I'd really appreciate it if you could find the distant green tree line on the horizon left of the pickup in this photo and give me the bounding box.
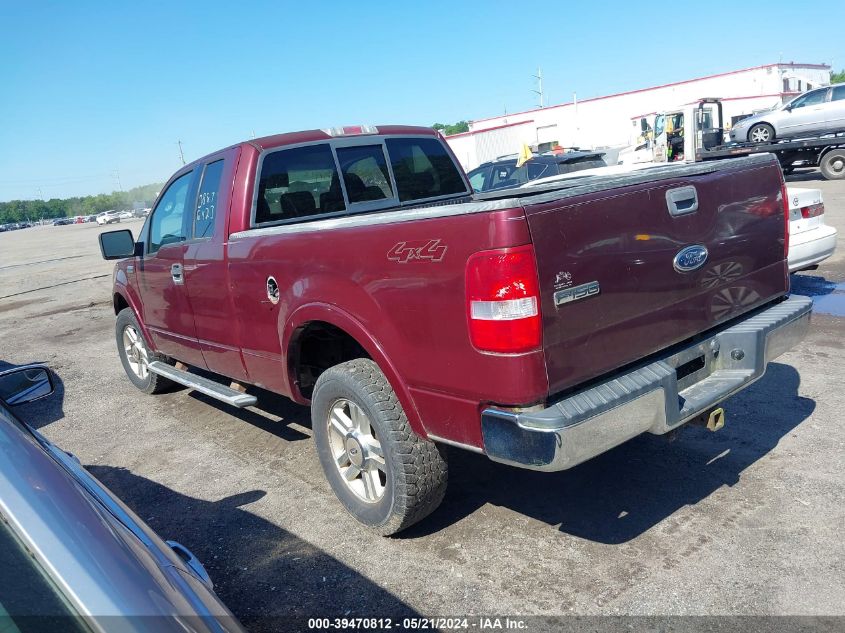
[0,183,163,224]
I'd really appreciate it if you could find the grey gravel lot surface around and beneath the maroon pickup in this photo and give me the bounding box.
[0,172,845,630]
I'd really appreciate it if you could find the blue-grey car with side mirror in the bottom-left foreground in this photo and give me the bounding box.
[0,365,242,632]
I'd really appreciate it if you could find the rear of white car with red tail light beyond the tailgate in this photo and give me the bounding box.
[787,187,836,273]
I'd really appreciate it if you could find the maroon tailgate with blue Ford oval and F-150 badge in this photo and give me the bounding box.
[523,155,789,393]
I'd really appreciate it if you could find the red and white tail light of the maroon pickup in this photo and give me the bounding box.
[466,246,541,354]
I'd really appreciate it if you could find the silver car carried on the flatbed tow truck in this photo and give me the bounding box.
[730,83,845,143]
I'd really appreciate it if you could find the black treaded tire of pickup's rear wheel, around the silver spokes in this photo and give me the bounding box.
[311,358,448,536]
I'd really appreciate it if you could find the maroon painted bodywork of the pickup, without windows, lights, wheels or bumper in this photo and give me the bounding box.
[109,126,788,448]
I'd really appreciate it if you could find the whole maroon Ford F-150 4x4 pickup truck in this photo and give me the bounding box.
[100,126,811,534]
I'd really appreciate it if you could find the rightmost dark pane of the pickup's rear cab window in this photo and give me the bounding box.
[385,138,466,202]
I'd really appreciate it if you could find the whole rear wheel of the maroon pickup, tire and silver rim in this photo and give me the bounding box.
[311,358,448,536]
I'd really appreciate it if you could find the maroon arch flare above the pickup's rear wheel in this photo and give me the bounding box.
[282,303,428,438]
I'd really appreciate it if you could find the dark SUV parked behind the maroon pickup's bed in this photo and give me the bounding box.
[467,152,606,192]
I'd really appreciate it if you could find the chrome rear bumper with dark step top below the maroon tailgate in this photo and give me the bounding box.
[481,296,813,471]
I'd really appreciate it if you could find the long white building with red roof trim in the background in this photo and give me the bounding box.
[446,62,830,170]
